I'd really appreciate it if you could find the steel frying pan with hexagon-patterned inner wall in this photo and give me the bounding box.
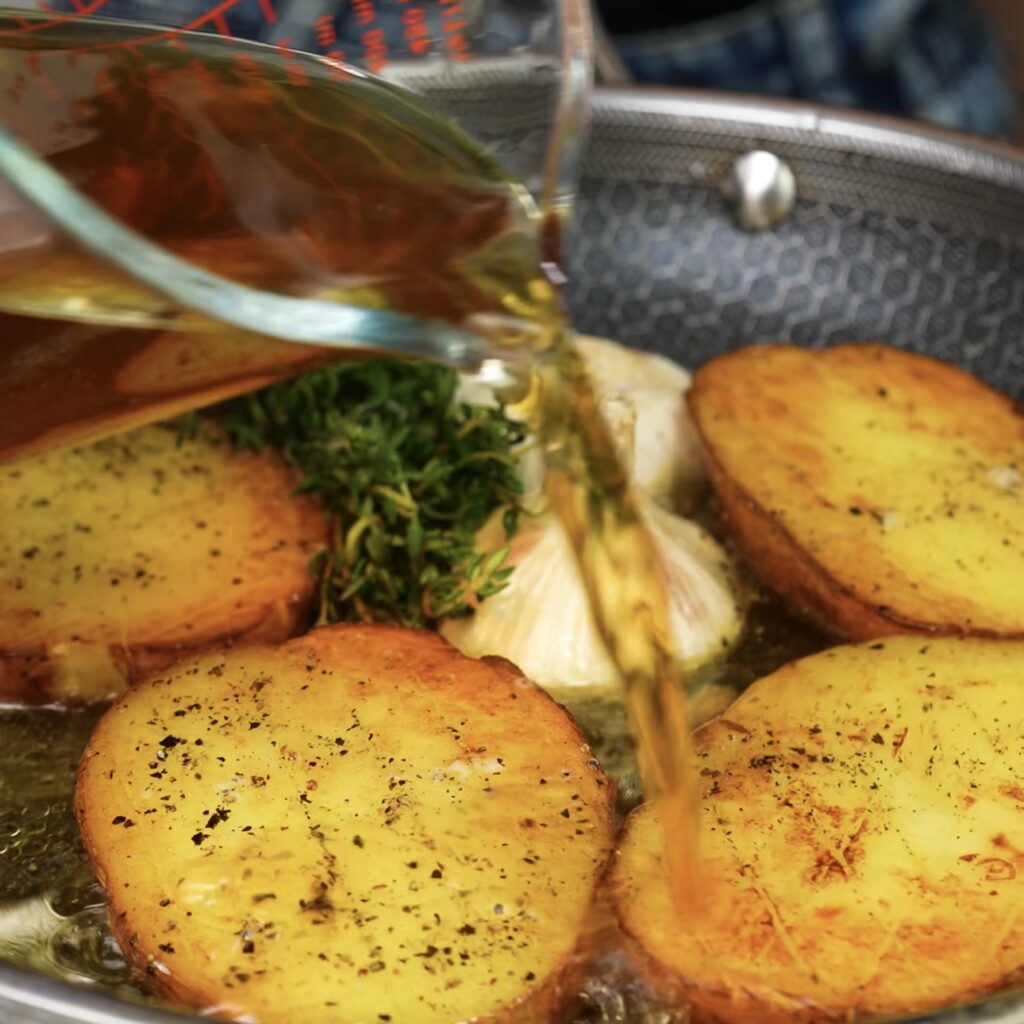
[0,89,1024,1024]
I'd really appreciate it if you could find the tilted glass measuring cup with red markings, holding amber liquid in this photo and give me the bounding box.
[0,0,589,459]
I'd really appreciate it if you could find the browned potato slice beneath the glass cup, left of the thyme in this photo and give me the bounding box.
[0,426,327,702]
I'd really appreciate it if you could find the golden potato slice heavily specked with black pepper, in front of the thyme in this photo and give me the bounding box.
[77,626,613,1024]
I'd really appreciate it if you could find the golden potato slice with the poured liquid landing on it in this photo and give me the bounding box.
[613,637,1024,1024]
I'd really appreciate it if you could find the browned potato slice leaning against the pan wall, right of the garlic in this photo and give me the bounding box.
[689,345,1024,639]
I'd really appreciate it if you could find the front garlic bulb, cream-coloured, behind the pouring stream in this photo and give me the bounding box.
[441,494,742,688]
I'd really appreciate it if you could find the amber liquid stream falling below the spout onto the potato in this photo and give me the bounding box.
[535,321,701,913]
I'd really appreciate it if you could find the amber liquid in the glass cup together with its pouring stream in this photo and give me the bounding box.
[0,19,697,909]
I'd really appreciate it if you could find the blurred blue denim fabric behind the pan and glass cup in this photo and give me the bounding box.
[29,0,1024,135]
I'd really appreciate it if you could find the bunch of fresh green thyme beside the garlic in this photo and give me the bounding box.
[214,359,524,626]
